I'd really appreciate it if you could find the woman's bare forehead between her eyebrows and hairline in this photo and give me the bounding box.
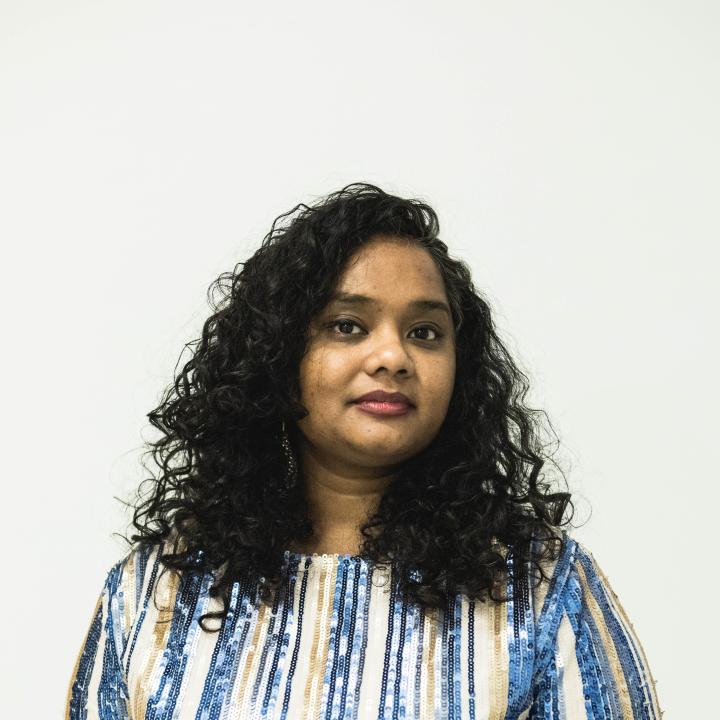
[335,236,446,302]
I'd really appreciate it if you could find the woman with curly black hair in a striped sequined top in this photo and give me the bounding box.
[67,184,661,720]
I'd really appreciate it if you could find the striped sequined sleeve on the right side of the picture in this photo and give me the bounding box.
[528,539,663,720]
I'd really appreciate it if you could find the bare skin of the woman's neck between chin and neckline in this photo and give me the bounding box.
[286,445,394,555]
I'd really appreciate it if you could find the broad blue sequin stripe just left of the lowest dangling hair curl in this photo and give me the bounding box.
[144,573,213,720]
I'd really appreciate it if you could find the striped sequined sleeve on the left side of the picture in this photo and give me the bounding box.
[65,553,141,720]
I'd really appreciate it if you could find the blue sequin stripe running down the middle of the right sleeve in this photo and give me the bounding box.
[565,569,617,719]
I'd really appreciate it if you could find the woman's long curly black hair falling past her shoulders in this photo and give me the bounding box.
[117,183,574,631]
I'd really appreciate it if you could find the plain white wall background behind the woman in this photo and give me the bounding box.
[0,0,720,718]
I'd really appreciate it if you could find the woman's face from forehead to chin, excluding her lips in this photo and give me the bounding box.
[298,236,455,470]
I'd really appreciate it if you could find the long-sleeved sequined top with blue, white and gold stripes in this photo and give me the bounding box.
[65,532,662,720]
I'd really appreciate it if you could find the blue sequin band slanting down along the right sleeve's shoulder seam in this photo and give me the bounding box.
[531,533,577,687]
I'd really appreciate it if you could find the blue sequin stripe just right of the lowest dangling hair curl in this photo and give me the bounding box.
[195,579,250,720]
